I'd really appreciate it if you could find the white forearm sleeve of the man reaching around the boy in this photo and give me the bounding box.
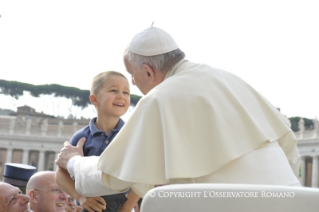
[73,156,119,197]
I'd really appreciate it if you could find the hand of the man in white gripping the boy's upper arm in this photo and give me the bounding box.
[55,137,86,169]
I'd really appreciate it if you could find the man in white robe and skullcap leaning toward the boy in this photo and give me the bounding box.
[56,27,300,207]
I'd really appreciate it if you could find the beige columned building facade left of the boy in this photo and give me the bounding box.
[0,110,90,175]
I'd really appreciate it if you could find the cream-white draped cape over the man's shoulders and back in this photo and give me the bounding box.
[75,60,299,196]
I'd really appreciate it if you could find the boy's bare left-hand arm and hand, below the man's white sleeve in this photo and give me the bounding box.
[55,166,106,212]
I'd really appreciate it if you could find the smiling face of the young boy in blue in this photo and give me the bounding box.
[95,75,130,117]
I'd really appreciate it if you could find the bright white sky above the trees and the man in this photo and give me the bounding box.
[0,0,319,119]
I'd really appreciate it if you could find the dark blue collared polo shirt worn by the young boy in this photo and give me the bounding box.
[70,118,124,156]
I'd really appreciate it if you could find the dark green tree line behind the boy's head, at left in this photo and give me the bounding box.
[0,80,141,108]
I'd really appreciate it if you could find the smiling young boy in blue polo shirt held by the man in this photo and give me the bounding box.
[56,71,139,212]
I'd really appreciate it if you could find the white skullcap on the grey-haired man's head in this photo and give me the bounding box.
[129,27,178,56]
